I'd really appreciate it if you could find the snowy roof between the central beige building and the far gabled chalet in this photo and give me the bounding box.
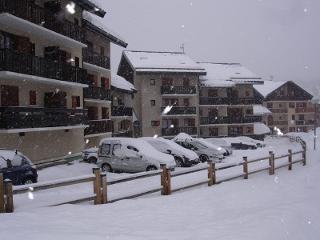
[198,62,261,87]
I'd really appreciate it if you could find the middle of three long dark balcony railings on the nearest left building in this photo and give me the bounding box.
[0,49,87,84]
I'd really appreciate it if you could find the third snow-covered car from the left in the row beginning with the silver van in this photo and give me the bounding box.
[173,135,226,162]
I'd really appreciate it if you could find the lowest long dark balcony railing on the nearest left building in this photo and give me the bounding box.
[0,107,88,129]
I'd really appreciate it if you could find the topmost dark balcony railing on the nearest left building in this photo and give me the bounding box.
[0,0,85,42]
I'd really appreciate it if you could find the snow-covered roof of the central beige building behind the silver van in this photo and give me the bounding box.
[123,51,205,74]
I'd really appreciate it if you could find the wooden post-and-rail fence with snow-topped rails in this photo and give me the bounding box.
[0,148,307,213]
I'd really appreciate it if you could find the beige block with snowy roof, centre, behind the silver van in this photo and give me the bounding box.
[118,51,205,138]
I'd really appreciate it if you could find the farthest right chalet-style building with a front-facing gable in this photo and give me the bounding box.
[254,81,315,133]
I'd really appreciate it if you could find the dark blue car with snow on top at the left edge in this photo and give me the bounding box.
[0,150,38,185]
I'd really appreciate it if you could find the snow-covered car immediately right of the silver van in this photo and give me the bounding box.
[141,137,200,167]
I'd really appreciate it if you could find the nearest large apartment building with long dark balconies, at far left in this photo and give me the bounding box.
[0,0,109,162]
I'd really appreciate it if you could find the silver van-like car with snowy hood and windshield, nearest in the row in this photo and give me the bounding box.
[97,138,176,173]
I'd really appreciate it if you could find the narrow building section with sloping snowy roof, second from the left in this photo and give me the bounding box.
[82,11,127,148]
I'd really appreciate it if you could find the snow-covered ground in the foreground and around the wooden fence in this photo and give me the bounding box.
[0,134,320,240]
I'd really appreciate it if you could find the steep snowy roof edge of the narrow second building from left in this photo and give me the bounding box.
[82,11,128,47]
